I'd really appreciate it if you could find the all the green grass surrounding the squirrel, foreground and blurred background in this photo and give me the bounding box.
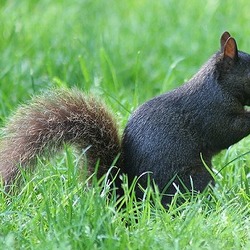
[0,0,250,249]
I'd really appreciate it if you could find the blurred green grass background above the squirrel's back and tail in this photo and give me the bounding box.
[0,0,250,123]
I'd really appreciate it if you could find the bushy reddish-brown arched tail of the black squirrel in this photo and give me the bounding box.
[0,89,120,184]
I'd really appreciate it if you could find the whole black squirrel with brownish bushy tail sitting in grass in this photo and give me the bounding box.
[0,32,250,202]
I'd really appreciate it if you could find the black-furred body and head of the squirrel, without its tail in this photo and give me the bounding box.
[122,32,250,202]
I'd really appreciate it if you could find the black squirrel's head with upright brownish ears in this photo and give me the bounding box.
[216,31,250,105]
